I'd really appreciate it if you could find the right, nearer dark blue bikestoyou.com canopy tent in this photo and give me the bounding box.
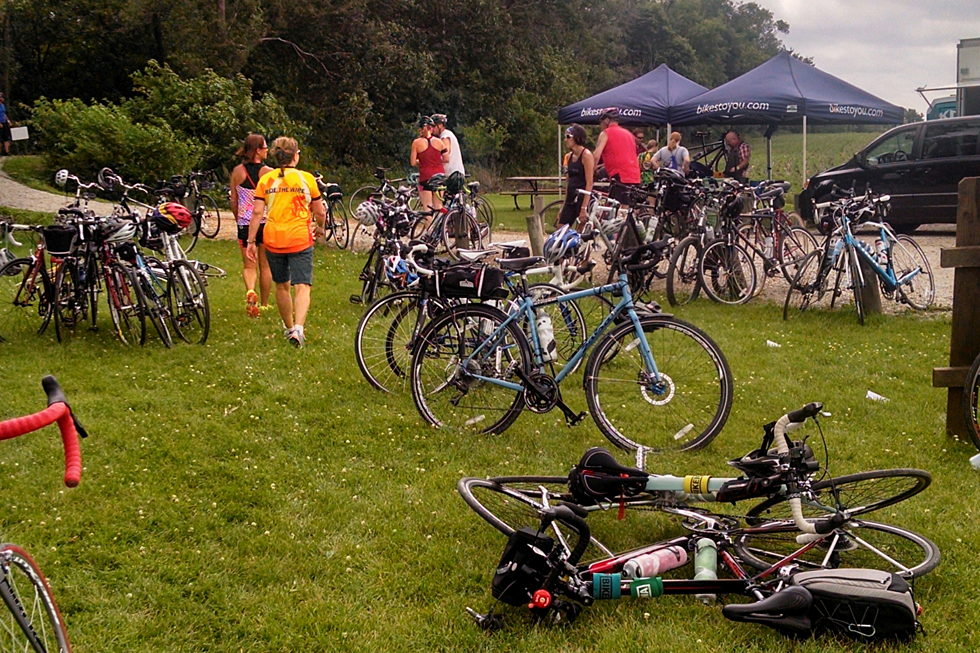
[670,52,905,178]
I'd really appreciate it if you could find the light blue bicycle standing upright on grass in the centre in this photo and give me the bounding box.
[411,243,732,450]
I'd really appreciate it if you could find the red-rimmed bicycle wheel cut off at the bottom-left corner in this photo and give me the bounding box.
[0,544,71,653]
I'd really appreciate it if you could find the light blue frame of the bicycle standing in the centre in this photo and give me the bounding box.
[460,274,661,392]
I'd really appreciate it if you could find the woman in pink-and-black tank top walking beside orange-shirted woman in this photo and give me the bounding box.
[229,134,272,317]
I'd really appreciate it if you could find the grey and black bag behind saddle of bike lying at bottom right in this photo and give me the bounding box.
[790,569,921,642]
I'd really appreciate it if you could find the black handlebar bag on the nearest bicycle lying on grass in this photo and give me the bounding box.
[490,526,555,606]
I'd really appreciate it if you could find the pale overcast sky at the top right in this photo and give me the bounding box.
[754,0,980,114]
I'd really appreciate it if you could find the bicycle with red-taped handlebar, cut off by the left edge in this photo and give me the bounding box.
[0,376,87,653]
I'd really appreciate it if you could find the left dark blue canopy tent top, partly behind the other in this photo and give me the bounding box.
[558,64,708,125]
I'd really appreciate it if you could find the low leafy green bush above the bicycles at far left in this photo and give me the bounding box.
[31,98,200,182]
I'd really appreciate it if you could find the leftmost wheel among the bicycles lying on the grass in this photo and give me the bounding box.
[456,476,613,563]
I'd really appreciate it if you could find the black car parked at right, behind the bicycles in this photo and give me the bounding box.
[796,116,980,233]
